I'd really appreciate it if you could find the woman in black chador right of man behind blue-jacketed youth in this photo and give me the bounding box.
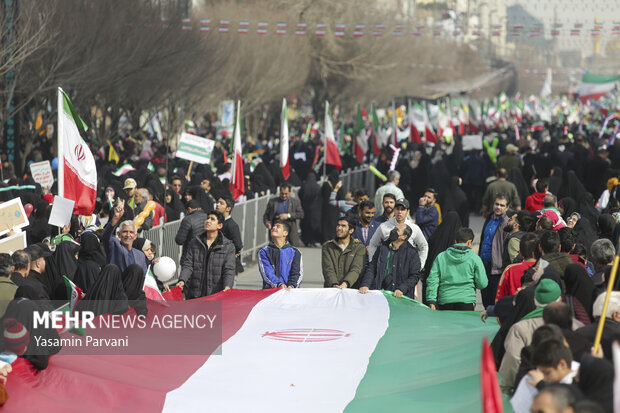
[299,172,321,246]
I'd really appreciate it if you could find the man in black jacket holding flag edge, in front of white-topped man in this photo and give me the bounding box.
[359,224,421,298]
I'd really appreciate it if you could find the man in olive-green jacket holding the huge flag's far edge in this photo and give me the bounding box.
[321,216,366,288]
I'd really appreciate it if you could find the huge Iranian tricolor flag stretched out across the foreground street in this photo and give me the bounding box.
[3,288,498,413]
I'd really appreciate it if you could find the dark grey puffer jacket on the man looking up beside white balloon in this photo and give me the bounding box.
[179,233,235,299]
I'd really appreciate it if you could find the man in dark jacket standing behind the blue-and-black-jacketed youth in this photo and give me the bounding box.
[263,182,304,247]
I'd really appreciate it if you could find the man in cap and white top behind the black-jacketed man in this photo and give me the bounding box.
[368,198,428,267]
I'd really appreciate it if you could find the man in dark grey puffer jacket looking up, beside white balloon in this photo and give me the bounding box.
[177,211,235,299]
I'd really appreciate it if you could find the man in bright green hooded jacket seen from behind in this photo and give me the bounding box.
[426,228,488,311]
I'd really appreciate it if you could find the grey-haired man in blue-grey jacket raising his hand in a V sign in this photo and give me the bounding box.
[101,201,147,274]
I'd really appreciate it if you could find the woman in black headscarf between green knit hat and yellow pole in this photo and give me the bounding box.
[564,264,595,324]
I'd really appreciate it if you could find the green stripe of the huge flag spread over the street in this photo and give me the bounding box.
[345,292,508,413]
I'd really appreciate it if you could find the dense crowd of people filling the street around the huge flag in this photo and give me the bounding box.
[0,100,620,412]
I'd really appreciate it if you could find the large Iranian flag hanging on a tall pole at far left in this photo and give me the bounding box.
[58,88,97,215]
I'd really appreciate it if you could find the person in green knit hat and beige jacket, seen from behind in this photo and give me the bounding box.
[499,278,562,393]
